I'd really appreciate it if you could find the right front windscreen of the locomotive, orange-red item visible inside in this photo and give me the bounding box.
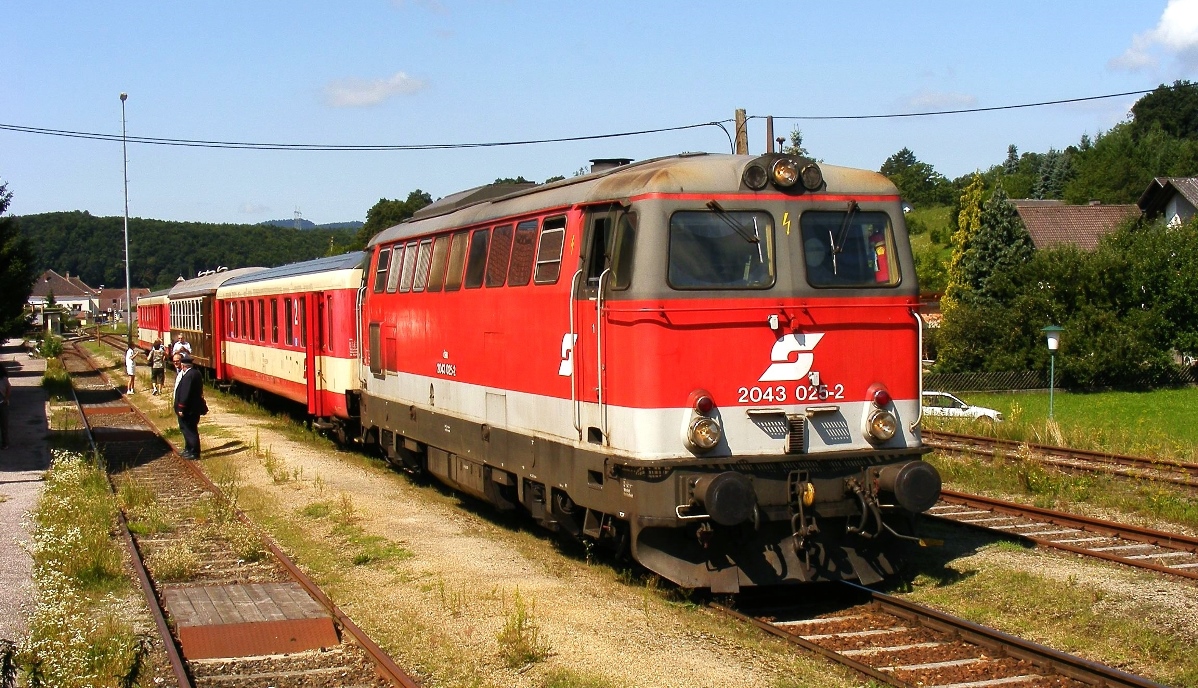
[799,204,900,288]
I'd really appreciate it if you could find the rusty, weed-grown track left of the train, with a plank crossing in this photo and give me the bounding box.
[63,346,418,688]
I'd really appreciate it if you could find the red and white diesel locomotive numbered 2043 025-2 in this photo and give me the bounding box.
[358,155,939,591]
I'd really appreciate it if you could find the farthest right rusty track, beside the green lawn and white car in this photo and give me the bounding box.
[921,430,1198,490]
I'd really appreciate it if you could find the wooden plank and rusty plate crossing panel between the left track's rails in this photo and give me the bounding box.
[163,583,340,659]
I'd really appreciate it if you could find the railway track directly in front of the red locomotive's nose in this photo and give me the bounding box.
[712,584,1160,688]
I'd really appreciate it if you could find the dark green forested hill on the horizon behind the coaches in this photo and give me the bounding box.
[17,211,355,289]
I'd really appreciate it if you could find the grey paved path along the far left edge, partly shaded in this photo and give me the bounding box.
[0,339,50,640]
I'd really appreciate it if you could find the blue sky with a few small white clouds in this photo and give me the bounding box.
[0,0,1198,223]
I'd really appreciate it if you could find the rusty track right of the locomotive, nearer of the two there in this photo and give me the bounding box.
[927,490,1198,579]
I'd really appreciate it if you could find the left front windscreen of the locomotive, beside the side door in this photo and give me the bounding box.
[668,205,774,289]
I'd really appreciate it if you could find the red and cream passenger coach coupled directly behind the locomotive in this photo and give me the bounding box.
[217,252,365,436]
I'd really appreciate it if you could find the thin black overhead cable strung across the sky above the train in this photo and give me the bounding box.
[0,89,1152,152]
